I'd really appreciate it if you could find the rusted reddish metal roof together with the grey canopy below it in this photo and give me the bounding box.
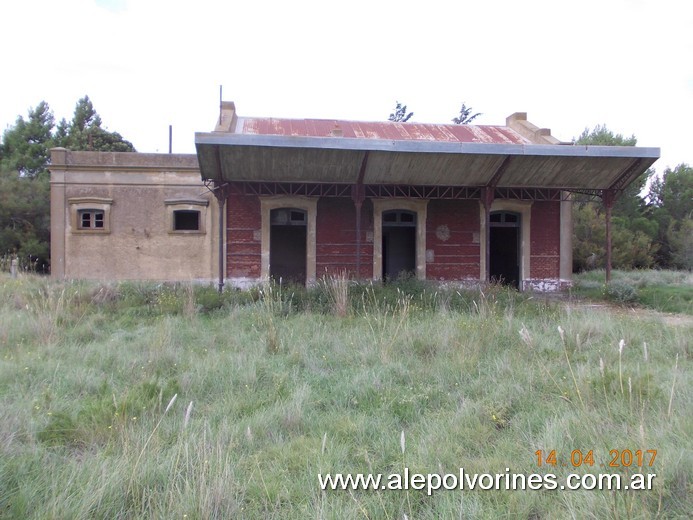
[195,107,659,191]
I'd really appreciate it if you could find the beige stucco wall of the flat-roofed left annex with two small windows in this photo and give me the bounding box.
[50,148,218,281]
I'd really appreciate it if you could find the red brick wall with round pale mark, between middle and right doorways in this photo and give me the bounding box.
[426,200,480,280]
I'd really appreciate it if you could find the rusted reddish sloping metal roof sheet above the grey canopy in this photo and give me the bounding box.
[236,117,531,144]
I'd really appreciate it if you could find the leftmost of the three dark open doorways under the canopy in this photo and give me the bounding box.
[269,208,308,285]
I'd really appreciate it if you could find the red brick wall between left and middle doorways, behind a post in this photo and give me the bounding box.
[315,198,373,278]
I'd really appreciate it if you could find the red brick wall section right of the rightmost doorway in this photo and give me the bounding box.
[529,201,561,279]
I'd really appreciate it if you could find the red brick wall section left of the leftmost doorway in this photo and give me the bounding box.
[226,192,262,278]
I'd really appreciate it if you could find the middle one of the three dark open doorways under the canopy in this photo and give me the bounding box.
[382,210,416,281]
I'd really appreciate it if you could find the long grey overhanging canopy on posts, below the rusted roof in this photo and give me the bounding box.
[195,132,659,191]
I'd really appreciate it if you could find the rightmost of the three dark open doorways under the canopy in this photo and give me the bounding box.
[489,211,520,289]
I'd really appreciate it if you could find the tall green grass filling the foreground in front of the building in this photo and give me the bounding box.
[0,275,693,519]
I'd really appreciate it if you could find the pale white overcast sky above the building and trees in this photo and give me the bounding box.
[0,0,693,172]
